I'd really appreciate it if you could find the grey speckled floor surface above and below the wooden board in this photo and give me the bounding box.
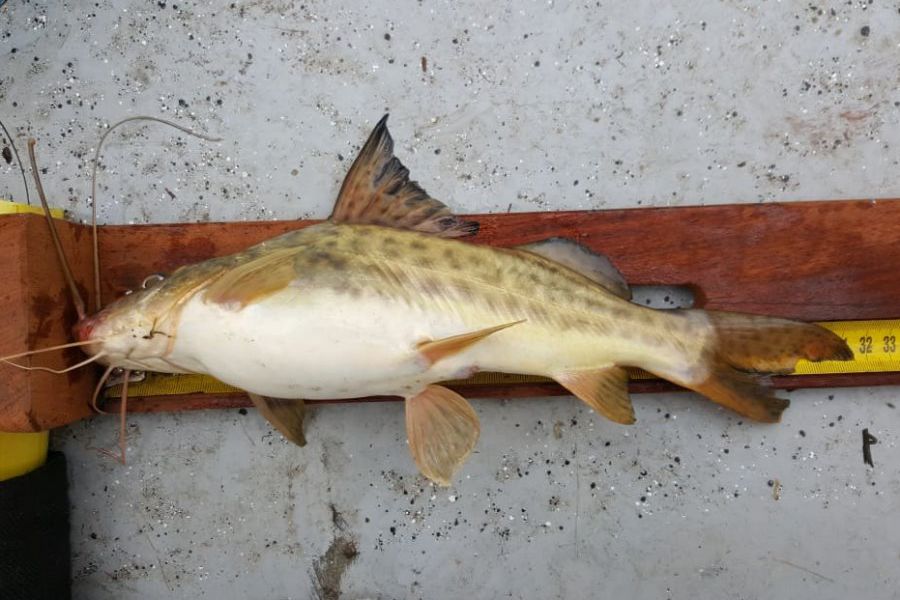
[0,0,900,599]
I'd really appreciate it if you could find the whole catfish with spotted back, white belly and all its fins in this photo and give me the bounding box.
[76,117,852,485]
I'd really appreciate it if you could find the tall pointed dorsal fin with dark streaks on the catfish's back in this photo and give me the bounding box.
[331,115,478,237]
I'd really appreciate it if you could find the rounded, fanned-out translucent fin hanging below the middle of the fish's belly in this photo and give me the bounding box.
[406,385,480,486]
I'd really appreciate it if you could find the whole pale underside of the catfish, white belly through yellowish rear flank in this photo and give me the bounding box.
[166,288,660,400]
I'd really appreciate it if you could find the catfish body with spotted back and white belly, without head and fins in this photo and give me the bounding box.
[167,223,711,399]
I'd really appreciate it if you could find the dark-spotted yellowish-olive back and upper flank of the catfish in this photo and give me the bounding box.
[220,223,686,356]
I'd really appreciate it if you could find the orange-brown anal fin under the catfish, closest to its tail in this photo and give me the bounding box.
[553,366,634,425]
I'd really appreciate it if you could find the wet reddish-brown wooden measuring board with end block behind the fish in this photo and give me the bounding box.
[0,199,900,429]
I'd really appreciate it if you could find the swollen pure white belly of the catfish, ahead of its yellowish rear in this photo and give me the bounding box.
[167,288,486,399]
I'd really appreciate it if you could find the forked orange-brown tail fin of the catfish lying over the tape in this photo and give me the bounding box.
[679,311,853,423]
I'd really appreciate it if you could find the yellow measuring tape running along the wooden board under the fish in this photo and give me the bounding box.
[107,319,900,398]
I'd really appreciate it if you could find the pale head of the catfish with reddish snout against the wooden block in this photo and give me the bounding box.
[74,278,185,372]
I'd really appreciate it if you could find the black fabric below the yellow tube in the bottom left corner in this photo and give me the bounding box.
[0,452,71,600]
